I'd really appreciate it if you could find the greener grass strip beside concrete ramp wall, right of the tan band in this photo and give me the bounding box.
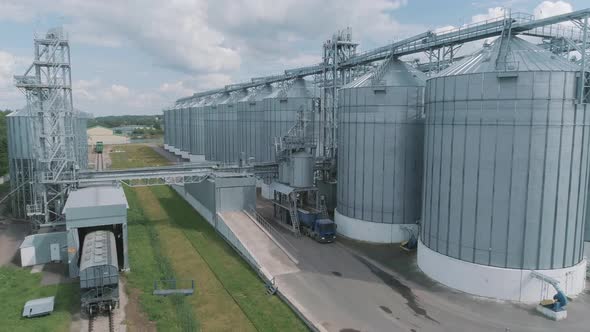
[151,187,307,331]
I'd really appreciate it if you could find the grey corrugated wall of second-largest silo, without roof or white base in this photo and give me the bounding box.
[337,87,424,224]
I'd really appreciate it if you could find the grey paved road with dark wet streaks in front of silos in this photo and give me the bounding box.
[257,198,590,332]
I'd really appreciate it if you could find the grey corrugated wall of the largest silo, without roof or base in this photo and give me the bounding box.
[421,72,590,269]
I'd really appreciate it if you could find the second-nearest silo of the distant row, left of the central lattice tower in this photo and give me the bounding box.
[237,85,273,161]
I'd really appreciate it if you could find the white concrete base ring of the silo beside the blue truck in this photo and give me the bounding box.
[334,209,417,243]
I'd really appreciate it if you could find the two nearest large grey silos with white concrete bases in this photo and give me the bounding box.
[335,37,590,303]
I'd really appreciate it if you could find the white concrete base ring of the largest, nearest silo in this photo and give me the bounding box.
[418,241,586,303]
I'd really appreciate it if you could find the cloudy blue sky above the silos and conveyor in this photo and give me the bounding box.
[0,0,590,116]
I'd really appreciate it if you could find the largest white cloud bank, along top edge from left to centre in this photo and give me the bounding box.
[0,0,421,74]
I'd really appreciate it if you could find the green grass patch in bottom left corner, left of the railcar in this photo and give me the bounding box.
[0,266,80,332]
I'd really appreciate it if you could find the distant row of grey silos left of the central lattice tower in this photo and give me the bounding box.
[164,79,319,164]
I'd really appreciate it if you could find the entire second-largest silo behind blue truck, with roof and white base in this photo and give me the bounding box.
[335,59,426,243]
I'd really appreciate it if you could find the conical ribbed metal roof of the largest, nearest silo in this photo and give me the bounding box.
[437,36,580,76]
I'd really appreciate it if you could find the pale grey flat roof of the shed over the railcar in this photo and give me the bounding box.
[64,186,129,210]
